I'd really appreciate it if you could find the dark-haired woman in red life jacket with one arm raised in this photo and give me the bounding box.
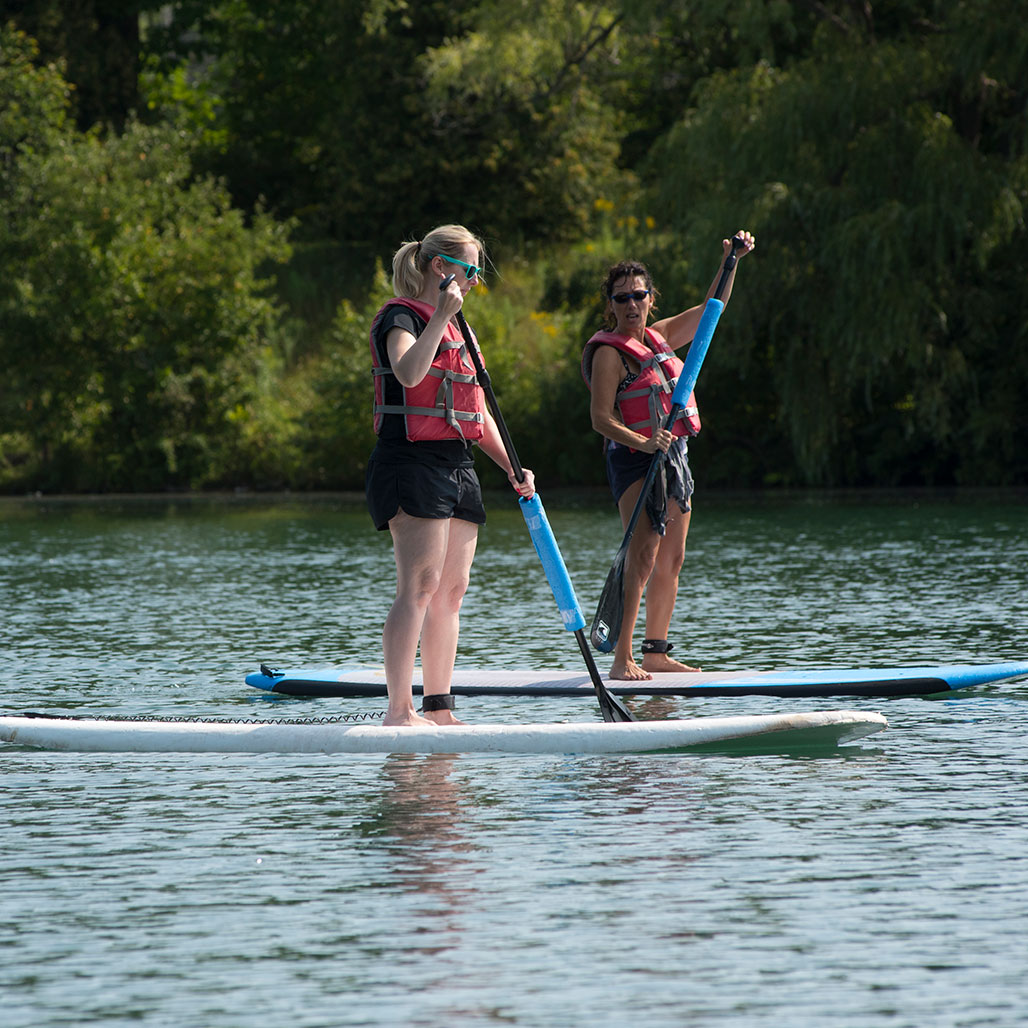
[582,231,756,682]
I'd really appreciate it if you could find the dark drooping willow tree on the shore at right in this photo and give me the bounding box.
[650,0,1028,484]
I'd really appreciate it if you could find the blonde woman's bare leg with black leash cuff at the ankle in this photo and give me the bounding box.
[421,518,478,725]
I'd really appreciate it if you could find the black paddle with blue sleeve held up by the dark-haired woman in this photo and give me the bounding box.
[589,236,743,653]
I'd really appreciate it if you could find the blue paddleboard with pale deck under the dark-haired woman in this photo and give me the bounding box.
[246,661,1028,697]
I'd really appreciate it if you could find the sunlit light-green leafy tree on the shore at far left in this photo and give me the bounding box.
[0,24,298,489]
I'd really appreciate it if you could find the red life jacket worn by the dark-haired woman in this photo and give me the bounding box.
[582,328,700,439]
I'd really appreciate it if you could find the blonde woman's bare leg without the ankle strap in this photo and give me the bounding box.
[382,510,450,725]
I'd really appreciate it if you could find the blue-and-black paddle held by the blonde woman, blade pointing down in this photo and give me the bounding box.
[439,276,637,721]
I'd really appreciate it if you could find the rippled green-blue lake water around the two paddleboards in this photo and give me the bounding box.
[0,494,1028,1028]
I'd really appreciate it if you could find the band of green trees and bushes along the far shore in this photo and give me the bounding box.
[0,0,1028,498]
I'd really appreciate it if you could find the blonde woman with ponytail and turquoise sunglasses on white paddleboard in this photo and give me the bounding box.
[366,225,535,725]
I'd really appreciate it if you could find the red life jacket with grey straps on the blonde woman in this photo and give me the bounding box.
[371,297,485,443]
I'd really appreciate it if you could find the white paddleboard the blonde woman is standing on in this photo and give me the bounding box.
[0,710,887,754]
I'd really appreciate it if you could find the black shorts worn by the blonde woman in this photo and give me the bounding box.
[364,457,485,531]
